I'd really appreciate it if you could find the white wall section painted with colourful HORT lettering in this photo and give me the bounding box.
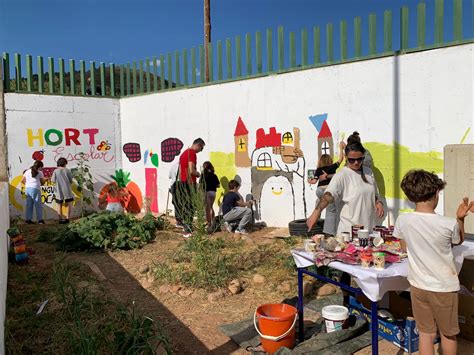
[5,93,121,218]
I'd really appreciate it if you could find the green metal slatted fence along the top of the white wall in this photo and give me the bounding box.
[2,0,474,97]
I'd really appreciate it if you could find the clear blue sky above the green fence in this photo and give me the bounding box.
[0,0,474,69]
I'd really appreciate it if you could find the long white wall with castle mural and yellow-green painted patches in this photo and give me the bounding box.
[120,44,474,226]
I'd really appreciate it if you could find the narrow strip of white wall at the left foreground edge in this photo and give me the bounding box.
[0,182,10,355]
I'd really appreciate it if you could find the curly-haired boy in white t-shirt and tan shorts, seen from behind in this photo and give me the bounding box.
[393,170,474,355]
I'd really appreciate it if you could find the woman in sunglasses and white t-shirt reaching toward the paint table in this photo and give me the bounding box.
[306,142,384,234]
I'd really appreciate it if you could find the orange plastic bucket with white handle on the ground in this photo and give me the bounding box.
[253,303,298,354]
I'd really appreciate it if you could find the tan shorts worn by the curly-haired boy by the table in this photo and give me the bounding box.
[410,286,459,336]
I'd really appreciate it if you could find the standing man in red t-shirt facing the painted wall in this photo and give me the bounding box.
[177,138,205,238]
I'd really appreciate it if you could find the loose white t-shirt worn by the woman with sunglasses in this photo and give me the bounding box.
[325,166,378,234]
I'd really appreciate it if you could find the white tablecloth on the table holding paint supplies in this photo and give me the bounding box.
[291,240,474,301]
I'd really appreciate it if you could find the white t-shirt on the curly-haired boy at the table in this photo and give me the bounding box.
[393,212,461,292]
